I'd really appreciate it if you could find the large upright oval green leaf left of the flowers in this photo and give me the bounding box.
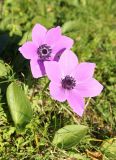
[7,82,32,128]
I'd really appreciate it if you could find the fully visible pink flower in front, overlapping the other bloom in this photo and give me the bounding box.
[44,50,103,116]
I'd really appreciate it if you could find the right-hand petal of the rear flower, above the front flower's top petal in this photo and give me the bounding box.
[53,36,74,53]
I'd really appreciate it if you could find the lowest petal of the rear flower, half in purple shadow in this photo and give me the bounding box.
[30,59,46,78]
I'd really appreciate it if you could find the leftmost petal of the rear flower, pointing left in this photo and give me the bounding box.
[19,42,38,59]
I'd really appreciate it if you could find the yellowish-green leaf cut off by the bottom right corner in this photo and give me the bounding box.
[101,138,116,160]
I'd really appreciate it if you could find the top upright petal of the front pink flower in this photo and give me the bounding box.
[58,50,78,76]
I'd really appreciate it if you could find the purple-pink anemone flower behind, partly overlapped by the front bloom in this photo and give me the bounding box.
[19,24,73,78]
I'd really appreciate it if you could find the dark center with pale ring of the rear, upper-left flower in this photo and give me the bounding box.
[37,44,52,60]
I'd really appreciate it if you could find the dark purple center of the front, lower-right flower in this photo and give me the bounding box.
[61,75,76,90]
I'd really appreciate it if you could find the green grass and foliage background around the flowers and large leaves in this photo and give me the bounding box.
[0,0,116,160]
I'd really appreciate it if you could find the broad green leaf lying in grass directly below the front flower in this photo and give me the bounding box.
[53,125,88,149]
